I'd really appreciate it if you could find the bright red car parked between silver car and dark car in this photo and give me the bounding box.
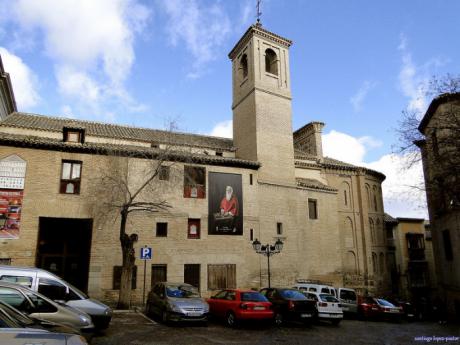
[207,289,273,327]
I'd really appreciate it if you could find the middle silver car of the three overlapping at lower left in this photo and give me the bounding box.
[0,282,94,336]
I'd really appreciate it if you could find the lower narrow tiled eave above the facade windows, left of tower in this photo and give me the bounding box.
[0,133,260,169]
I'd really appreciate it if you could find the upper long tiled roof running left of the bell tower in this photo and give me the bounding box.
[0,113,235,151]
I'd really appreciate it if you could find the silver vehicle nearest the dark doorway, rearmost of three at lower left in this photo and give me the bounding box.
[0,265,112,329]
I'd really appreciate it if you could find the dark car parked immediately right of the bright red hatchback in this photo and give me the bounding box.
[260,288,318,325]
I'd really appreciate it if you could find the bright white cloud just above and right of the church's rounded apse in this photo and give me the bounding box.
[323,130,428,218]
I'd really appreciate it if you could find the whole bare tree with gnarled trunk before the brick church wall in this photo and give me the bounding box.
[92,125,191,309]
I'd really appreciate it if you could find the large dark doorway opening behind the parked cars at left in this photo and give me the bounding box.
[35,217,93,292]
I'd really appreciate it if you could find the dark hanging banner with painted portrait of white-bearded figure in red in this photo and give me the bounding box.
[208,172,243,235]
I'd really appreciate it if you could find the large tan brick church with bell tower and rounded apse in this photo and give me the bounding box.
[0,25,389,303]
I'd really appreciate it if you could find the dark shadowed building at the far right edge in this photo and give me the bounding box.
[416,93,460,318]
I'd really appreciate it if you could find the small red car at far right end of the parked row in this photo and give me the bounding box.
[358,297,404,320]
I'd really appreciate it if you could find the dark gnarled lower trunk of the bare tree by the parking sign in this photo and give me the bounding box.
[117,211,137,309]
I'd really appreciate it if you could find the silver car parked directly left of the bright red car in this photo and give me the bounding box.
[146,282,209,322]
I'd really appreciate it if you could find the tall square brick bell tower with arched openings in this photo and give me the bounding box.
[229,24,295,185]
